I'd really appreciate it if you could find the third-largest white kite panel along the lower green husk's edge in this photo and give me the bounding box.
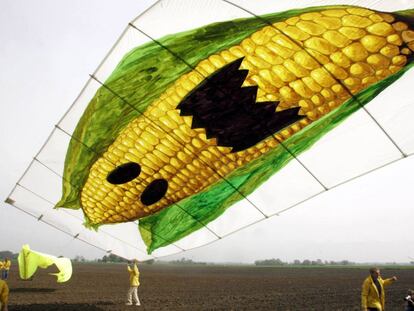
[207,200,265,237]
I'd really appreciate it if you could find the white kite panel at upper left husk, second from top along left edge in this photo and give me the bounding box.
[94,25,151,82]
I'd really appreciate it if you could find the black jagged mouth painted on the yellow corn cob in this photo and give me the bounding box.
[177,58,304,152]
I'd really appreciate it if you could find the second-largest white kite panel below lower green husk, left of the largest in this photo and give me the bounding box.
[248,160,324,216]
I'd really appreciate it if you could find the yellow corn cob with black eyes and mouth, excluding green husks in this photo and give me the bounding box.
[60,6,414,239]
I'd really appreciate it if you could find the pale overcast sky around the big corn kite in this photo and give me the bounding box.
[0,0,414,262]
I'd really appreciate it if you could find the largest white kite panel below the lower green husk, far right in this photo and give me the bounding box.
[298,110,401,188]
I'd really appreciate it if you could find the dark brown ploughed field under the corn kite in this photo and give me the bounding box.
[4,264,414,311]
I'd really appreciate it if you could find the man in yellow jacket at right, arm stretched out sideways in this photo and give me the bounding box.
[361,267,397,311]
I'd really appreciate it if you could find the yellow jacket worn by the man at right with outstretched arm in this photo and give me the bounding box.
[361,276,394,311]
